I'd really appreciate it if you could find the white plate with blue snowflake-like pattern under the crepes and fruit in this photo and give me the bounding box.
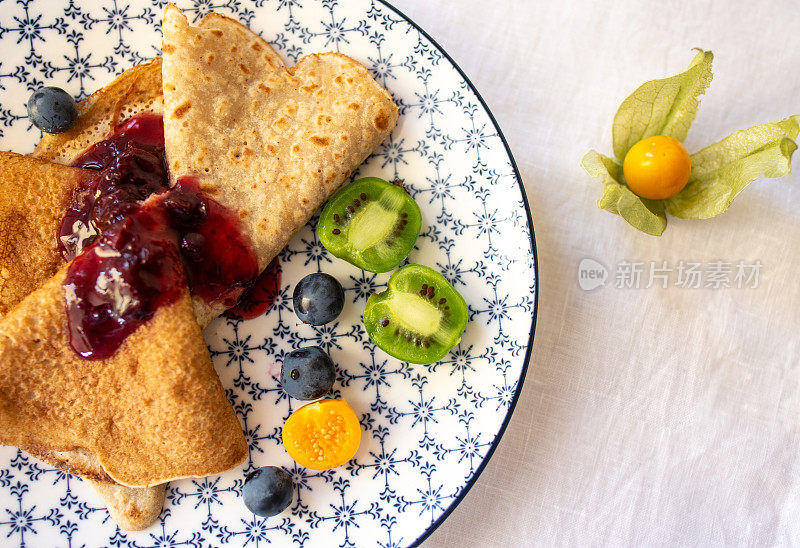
[0,0,537,547]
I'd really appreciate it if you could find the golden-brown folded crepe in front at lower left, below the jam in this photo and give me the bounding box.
[0,266,247,487]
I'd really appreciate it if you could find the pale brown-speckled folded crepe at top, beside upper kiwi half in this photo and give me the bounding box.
[162,5,398,325]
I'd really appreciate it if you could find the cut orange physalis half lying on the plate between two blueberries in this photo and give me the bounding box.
[282,400,361,470]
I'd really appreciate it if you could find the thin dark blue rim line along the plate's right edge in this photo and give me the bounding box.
[378,0,539,548]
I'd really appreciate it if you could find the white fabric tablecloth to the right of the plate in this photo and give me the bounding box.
[396,0,800,547]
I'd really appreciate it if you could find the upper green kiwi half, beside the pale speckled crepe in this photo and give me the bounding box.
[317,177,422,272]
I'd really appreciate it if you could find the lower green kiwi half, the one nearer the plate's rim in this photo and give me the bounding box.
[364,264,468,363]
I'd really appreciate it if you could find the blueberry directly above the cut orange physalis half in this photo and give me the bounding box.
[281,346,336,400]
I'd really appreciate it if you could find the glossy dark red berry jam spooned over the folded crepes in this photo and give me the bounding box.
[59,114,258,359]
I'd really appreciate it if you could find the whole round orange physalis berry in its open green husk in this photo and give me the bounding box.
[622,135,692,200]
